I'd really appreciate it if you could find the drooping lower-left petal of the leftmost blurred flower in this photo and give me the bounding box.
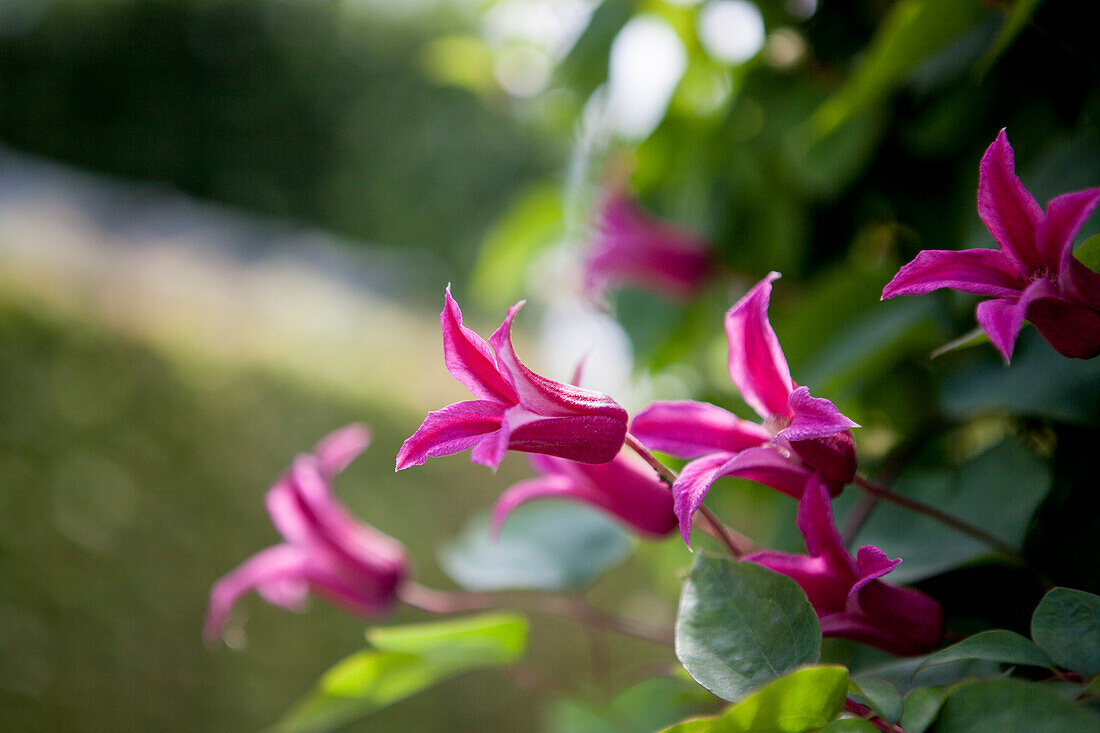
[202,545,309,644]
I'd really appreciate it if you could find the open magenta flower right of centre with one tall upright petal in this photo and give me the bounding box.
[630,272,859,543]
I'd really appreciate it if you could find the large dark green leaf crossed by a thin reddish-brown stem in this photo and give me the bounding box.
[857,433,1052,583]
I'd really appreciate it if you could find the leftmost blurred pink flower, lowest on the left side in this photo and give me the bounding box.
[204,425,409,643]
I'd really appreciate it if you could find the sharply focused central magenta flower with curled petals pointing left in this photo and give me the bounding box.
[396,287,627,471]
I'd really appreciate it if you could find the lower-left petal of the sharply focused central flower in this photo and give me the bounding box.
[395,400,505,471]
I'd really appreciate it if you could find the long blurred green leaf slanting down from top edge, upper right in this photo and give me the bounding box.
[811,0,983,139]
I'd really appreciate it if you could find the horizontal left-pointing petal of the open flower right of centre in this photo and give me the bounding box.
[630,401,771,458]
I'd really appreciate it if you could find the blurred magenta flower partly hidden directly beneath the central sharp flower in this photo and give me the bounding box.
[493,451,677,537]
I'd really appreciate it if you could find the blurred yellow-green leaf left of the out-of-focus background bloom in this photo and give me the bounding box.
[472,186,564,308]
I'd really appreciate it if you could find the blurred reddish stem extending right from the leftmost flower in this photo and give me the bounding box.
[398,581,673,646]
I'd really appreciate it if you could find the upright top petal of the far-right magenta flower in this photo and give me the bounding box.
[978,130,1043,272]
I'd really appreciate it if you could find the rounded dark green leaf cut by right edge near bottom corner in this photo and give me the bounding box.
[1032,588,1100,678]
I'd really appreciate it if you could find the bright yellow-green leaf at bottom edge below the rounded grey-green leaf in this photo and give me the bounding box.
[666,666,848,733]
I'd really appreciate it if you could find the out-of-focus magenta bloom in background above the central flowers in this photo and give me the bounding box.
[584,193,714,300]
